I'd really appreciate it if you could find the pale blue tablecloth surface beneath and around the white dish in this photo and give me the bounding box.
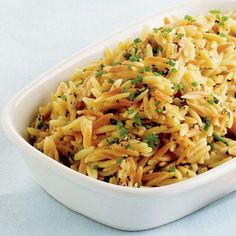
[0,0,236,236]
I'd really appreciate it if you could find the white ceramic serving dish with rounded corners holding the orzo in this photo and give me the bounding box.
[2,0,236,230]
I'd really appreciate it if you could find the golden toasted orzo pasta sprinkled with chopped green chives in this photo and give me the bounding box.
[27,10,236,187]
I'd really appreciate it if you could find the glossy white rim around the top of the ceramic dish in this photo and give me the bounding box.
[1,0,236,195]
